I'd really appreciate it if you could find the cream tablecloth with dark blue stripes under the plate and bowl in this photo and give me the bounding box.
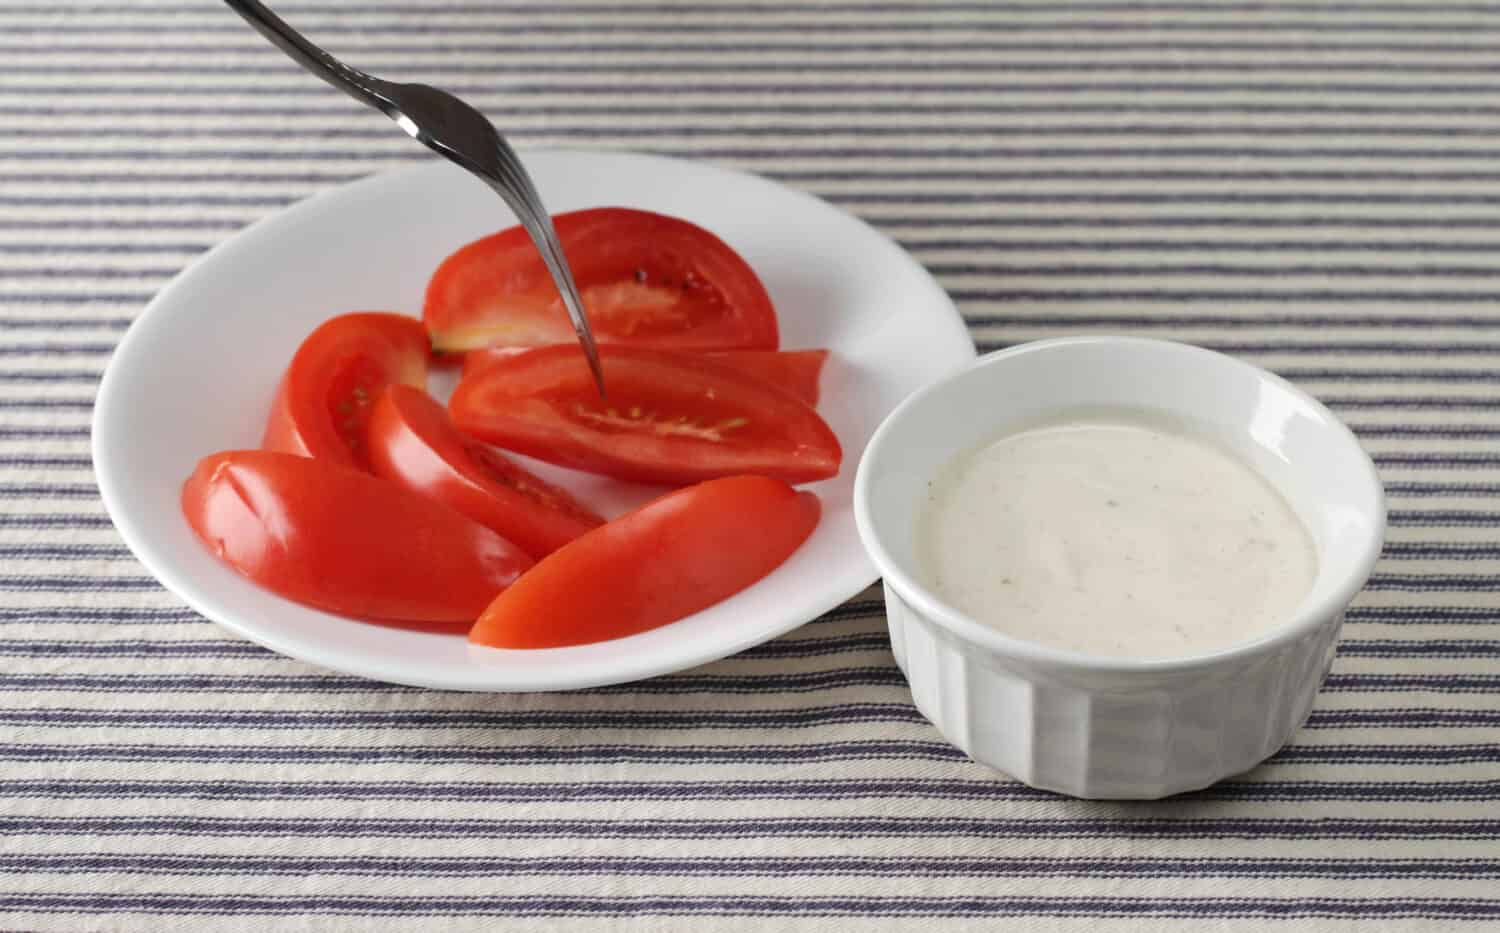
[0,0,1500,930]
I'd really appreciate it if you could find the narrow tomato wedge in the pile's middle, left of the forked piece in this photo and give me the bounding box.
[369,386,605,558]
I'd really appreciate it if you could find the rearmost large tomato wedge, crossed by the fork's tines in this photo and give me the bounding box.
[422,207,777,353]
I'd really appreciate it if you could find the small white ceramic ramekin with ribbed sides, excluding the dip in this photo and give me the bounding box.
[855,338,1386,798]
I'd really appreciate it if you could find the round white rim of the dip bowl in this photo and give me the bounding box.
[854,336,1386,674]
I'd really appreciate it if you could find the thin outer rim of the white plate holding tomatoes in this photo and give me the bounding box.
[90,147,977,693]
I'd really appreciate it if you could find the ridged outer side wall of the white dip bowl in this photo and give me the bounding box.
[885,585,1343,800]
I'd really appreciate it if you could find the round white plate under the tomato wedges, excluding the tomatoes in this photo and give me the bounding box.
[93,152,974,690]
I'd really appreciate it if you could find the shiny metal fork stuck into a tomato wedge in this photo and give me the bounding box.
[224,0,605,395]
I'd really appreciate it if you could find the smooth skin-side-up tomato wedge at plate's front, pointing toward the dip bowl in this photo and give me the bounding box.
[470,476,822,648]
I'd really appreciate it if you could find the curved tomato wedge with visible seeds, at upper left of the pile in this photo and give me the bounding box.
[261,312,428,470]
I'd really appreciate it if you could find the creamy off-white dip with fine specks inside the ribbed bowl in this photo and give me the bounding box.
[917,413,1317,659]
